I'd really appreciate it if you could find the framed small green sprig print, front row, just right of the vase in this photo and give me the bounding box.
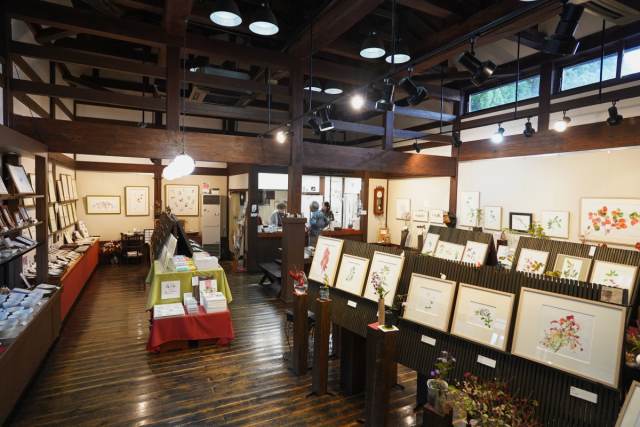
[403,273,456,332]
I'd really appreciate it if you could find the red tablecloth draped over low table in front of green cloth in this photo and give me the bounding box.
[147,305,234,353]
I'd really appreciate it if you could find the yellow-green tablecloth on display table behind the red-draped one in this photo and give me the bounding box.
[146,260,233,310]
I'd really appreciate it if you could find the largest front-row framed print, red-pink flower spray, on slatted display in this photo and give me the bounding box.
[511,288,626,388]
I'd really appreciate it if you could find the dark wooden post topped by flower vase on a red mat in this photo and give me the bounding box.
[364,323,398,427]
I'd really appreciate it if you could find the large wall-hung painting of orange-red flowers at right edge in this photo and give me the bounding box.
[580,197,640,246]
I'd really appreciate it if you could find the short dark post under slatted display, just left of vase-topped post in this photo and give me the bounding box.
[340,328,367,395]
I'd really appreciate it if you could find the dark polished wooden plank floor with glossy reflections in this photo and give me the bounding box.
[9,264,422,426]
